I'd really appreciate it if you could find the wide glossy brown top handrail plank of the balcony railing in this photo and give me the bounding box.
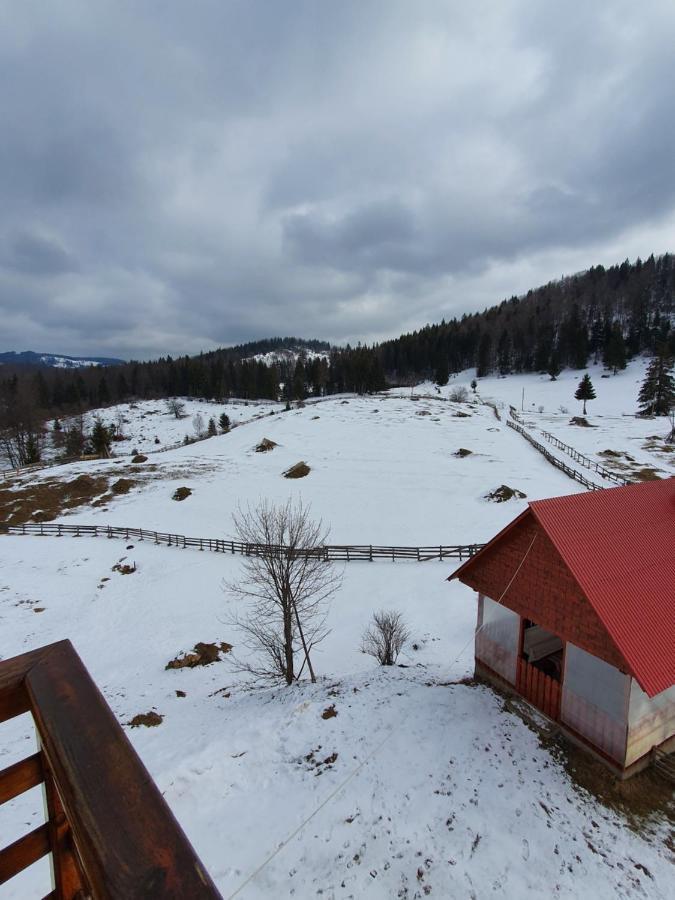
[26,641,220,900]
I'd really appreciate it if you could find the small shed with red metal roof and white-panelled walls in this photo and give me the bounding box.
[451,478,675,777]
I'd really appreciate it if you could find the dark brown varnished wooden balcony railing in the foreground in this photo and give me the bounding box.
[0,641,221,900]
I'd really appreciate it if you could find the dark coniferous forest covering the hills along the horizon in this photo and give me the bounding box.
[0,254,675,444]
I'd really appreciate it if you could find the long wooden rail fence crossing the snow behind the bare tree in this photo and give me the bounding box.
[0,522,483,562]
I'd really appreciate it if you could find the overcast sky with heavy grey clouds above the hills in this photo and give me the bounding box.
[0,0,675,358]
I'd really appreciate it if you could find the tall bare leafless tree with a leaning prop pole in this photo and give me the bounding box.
[225,500,342,684]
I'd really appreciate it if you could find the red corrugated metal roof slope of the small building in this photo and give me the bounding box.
[529,478,675,697]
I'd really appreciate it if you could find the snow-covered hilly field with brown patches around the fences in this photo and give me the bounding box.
[0,363,675,898]
